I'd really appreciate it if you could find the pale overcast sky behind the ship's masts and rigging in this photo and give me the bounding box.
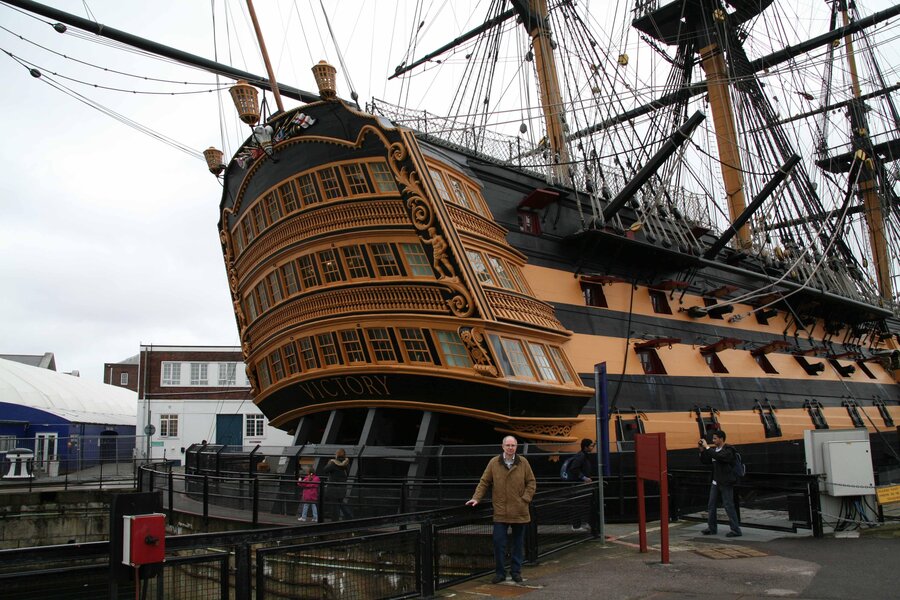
[0,0,891,381]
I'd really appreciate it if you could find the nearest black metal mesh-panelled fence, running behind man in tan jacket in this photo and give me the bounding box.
[0,485,597,600]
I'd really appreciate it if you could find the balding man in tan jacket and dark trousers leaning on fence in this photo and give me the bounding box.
[466,435,537,583]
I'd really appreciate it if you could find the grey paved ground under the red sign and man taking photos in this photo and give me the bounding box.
[437,516,900,600]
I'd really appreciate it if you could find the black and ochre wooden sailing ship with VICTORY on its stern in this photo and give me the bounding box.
[14,0,900,475]
